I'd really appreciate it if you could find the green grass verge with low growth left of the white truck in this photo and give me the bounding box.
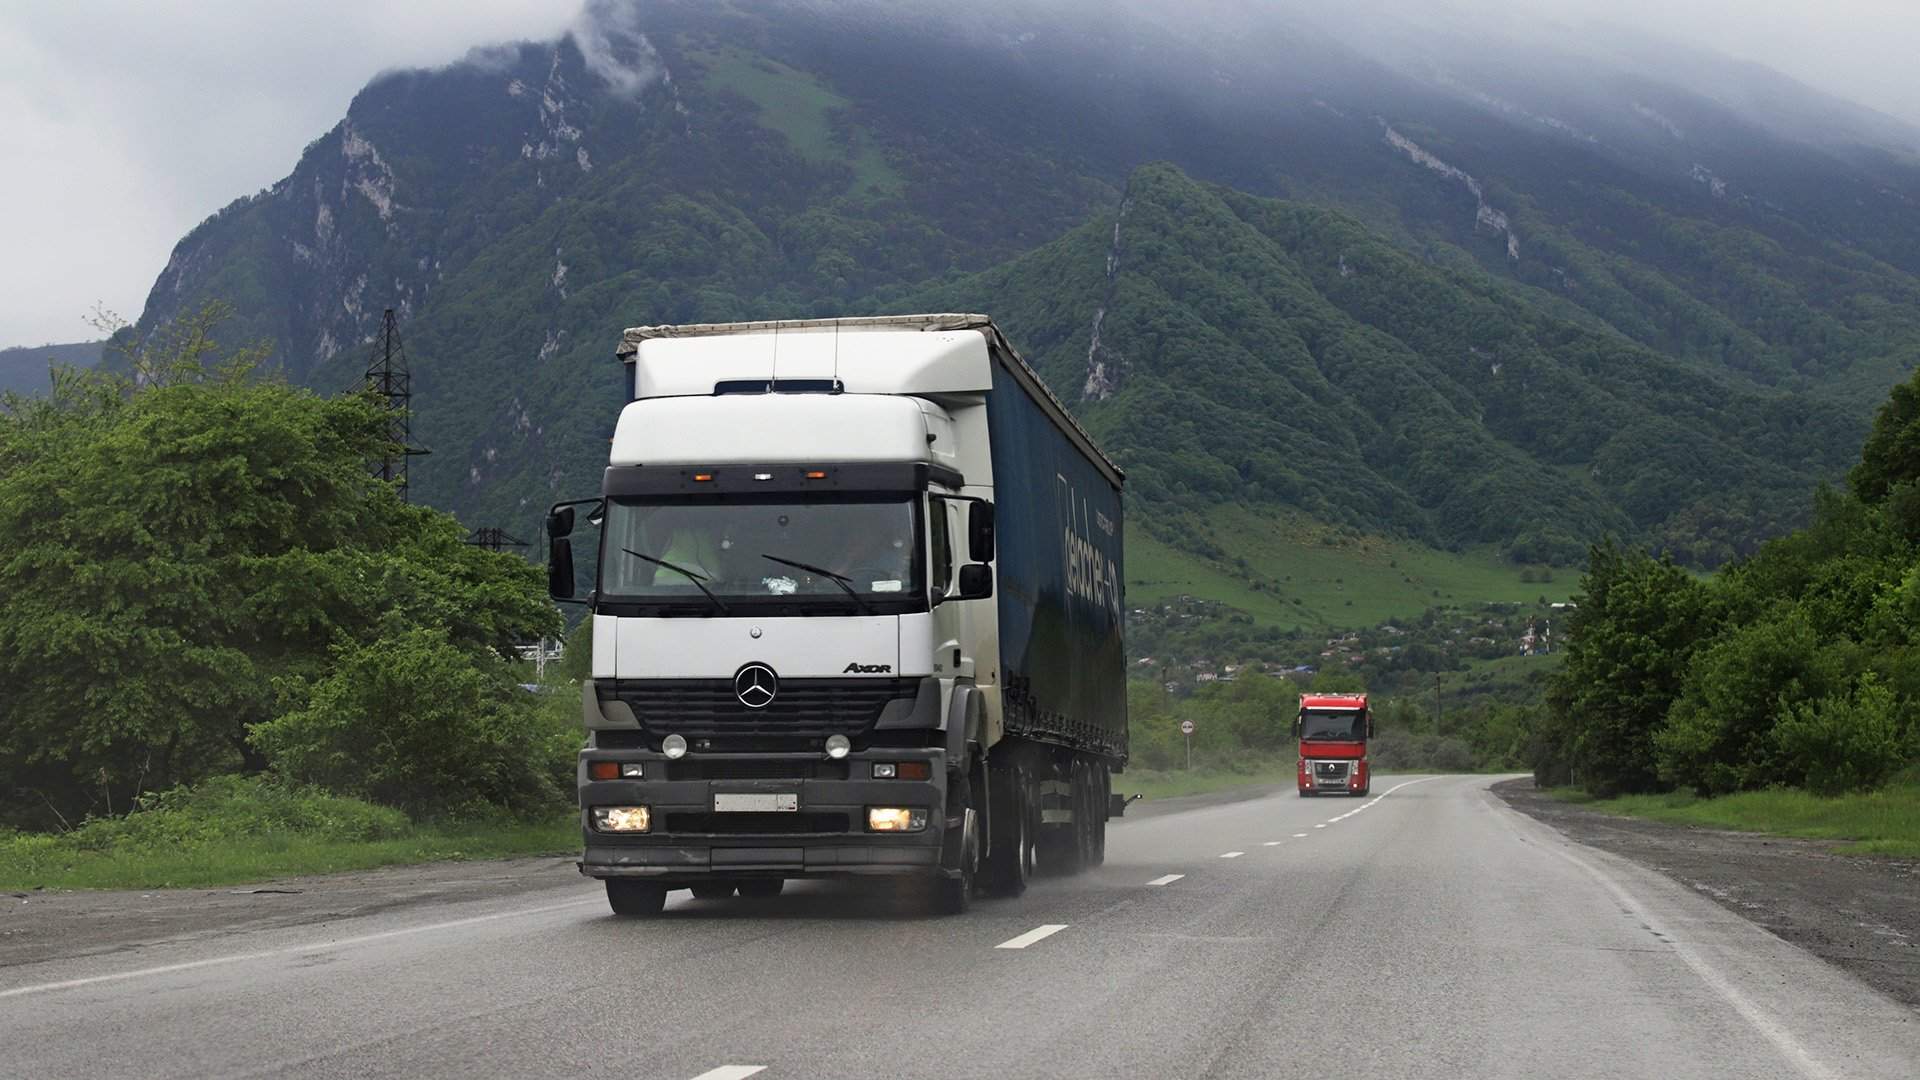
[0,778,580,892]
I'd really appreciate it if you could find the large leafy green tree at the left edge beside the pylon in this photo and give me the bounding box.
[0,307,559,819]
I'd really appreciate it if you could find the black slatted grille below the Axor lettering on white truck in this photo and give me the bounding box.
[612,678,920,738]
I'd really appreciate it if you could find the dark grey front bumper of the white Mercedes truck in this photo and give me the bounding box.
[580,749,947,884]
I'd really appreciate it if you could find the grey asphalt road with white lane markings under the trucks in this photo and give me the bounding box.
[0,776,1920,1080]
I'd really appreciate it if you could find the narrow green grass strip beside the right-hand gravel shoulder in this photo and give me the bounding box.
[1551,782,1920,859]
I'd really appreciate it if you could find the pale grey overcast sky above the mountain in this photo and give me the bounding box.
[0,0,1920,346]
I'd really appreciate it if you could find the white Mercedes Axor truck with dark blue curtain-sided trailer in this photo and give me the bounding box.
[547,315,1127,917]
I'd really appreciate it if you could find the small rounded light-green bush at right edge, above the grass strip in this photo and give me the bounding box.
[1774,673,1908,796]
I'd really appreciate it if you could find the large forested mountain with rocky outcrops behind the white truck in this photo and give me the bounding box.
[127,0,1920,580]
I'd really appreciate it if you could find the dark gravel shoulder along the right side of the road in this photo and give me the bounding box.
[1492,780,1920,1007]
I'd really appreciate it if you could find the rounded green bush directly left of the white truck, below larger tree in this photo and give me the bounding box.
[252,628,580,819]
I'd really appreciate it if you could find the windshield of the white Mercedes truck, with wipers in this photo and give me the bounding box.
[599,496,925,613]
